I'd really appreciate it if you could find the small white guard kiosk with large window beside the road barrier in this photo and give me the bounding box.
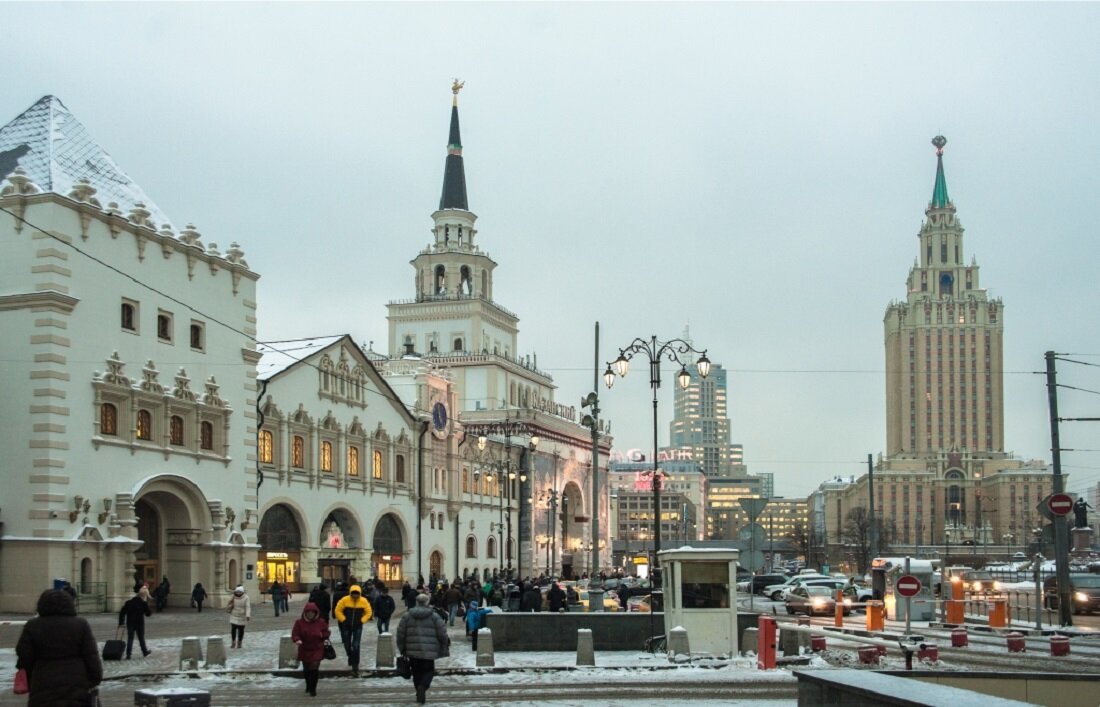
[659,546,740,656]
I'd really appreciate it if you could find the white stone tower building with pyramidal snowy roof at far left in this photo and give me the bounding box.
[0,96,259,611]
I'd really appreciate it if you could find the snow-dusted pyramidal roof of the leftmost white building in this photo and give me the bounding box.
[0,96,172,227]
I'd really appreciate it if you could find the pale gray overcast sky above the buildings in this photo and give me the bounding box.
[0,2,1100,496]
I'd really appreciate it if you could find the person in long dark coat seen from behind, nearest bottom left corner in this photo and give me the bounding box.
[15,589,103,707]
